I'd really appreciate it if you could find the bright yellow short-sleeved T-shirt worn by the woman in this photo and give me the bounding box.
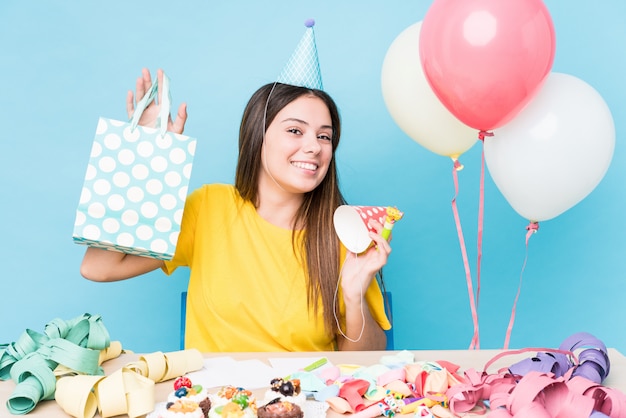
[165,184,390,352]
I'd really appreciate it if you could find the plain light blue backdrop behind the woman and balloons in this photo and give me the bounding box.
[0,0,626,352]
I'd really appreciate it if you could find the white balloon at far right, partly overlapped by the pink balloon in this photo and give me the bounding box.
[484,72,615,222]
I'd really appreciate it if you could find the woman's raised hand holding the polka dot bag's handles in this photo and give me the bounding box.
[126,68,187,134]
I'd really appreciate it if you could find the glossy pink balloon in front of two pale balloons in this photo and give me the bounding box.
[419,0,555,131]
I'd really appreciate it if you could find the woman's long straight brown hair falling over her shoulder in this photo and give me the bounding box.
[235,83,345,337]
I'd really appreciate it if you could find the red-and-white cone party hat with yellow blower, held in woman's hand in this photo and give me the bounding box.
[333,205,404,254]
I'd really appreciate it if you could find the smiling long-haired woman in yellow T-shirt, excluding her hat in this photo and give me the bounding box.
[81,69,391,352]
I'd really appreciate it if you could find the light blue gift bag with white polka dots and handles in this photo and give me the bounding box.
[73,74,196,260]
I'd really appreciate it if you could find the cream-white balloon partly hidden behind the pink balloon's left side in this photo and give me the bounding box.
[381,22,478,158]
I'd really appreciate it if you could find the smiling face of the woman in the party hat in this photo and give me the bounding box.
[260,96,333,194]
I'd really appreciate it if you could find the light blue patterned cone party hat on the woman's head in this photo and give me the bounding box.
[276,19,323,90]
